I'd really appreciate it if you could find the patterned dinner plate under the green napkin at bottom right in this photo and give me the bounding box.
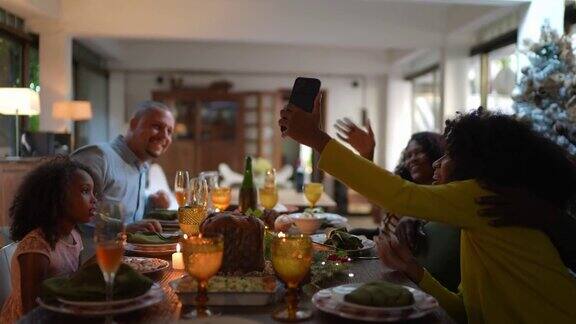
[312,284,438,322]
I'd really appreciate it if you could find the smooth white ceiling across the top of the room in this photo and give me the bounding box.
[0,0,526,70]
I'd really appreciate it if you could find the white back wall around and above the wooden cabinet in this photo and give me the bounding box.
[121,71,381,166]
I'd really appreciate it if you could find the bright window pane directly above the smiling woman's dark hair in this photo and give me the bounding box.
[408,66,442,132]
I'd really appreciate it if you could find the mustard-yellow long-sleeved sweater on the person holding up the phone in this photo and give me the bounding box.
[319,140,576,324]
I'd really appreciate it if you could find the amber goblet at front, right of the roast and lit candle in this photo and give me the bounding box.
[270,232,312,322]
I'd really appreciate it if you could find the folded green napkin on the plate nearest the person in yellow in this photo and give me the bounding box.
[344,281,414,307]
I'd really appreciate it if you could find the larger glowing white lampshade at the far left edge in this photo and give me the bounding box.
[0,88,40,115]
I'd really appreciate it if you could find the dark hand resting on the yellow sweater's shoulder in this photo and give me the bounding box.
[476,184,561,229]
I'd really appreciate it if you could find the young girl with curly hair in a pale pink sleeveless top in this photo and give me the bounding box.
[0,157,96,323]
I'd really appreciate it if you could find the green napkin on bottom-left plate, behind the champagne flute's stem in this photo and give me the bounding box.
[40,263,153,301]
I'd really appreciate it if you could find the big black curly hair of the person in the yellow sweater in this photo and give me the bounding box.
[444,107,576,206]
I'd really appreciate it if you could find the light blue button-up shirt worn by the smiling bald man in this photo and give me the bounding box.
[72,135,149,224]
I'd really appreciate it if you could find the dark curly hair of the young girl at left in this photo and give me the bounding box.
[9,156,98,249]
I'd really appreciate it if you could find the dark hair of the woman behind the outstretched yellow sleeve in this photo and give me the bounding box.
[394,132,446,181]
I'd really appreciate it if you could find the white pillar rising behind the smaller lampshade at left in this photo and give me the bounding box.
[40,32,72,132]
